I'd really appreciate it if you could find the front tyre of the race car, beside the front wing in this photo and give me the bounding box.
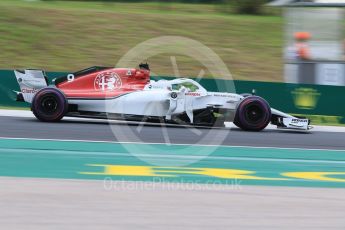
[234,96,271,131]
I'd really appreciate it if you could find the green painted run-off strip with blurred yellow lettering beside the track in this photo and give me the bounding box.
[0,139,345,187]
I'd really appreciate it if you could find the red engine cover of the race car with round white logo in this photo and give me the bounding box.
[56,68,150,99]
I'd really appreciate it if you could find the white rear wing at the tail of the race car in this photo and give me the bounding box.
[14,69,48,103]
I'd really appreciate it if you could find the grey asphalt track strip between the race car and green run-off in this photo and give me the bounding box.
[0,117,345,150]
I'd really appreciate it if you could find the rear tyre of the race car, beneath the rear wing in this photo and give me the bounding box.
[31,88,68,122]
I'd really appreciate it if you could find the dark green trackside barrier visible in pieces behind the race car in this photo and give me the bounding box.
[0,70,345,124]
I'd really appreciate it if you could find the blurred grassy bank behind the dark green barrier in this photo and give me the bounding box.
[0,0,283,81]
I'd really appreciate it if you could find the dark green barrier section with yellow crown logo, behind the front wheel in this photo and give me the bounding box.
[235,81,345,124]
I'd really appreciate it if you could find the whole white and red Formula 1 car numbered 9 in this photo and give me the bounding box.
[14,64,311,131]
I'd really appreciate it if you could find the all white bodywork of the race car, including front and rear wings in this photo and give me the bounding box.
[15,70,311,130]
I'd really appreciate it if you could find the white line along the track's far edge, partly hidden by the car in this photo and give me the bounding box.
[0,109,345,133]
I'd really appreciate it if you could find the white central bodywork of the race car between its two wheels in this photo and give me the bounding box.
[69,79,243,120]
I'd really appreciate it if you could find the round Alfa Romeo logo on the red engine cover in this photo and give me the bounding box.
[94,72,122,91]
